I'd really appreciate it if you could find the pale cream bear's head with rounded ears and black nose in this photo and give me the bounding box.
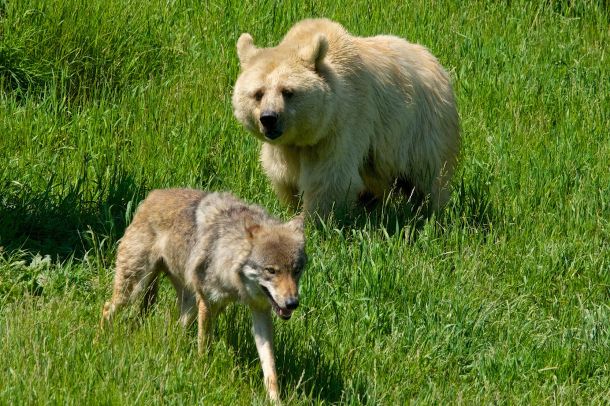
[233,34,333,146]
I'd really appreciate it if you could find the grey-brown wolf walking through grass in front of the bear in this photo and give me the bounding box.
[101,189,307,401]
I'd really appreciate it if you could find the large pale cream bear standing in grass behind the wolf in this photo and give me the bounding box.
[232,18,460,217]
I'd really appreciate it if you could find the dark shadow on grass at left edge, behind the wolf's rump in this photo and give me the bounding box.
[0,170,145,260]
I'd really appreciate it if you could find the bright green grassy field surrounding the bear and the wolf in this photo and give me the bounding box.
[0,0,610,405]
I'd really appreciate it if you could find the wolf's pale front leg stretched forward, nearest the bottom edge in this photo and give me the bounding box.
[252,310,280,402]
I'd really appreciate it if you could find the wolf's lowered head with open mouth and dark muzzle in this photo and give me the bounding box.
[243,216,307,320]
